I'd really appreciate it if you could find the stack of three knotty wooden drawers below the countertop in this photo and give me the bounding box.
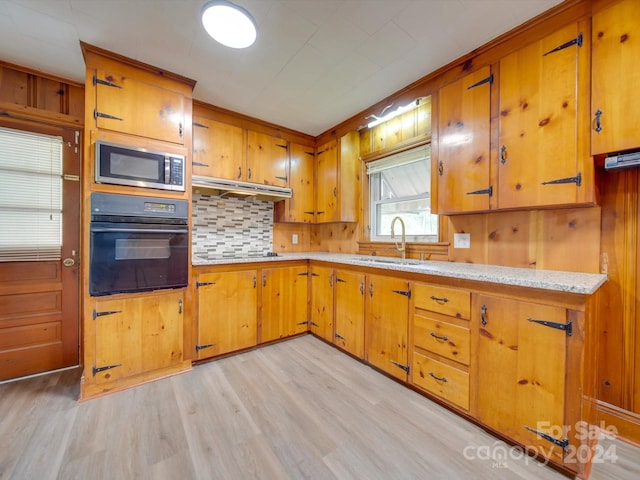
[410,283,471,410]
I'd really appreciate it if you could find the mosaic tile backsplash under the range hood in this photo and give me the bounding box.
[192,193,273,258]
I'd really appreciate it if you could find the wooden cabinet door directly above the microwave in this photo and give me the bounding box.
[94,70,185,144]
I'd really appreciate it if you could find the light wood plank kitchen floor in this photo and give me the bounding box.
[0,336,640,480]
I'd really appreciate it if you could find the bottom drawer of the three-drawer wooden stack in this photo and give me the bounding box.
[413,352,469,410]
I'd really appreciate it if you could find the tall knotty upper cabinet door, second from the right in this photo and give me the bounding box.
[498,24,588,209]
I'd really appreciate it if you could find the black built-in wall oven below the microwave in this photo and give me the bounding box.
[89,193,189,296]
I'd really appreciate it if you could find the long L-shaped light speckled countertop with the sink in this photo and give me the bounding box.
[192,252,607,295]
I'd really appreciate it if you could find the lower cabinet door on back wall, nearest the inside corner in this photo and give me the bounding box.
[261,266,309,342]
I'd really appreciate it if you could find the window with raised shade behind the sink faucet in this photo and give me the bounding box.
[367,145,438,242]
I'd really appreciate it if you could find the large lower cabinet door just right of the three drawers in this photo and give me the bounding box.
[472,295,568,461]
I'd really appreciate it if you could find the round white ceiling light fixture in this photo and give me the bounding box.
[202,0,256,48]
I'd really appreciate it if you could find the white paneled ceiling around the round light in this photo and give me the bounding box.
[0,0,562,136]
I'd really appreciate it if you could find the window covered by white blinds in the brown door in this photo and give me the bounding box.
[0,128,62,261]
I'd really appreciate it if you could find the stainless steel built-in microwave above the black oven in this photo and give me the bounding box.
[96,140,185,192]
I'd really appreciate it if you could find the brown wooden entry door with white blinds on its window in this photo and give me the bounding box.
[0,120,81,381]
